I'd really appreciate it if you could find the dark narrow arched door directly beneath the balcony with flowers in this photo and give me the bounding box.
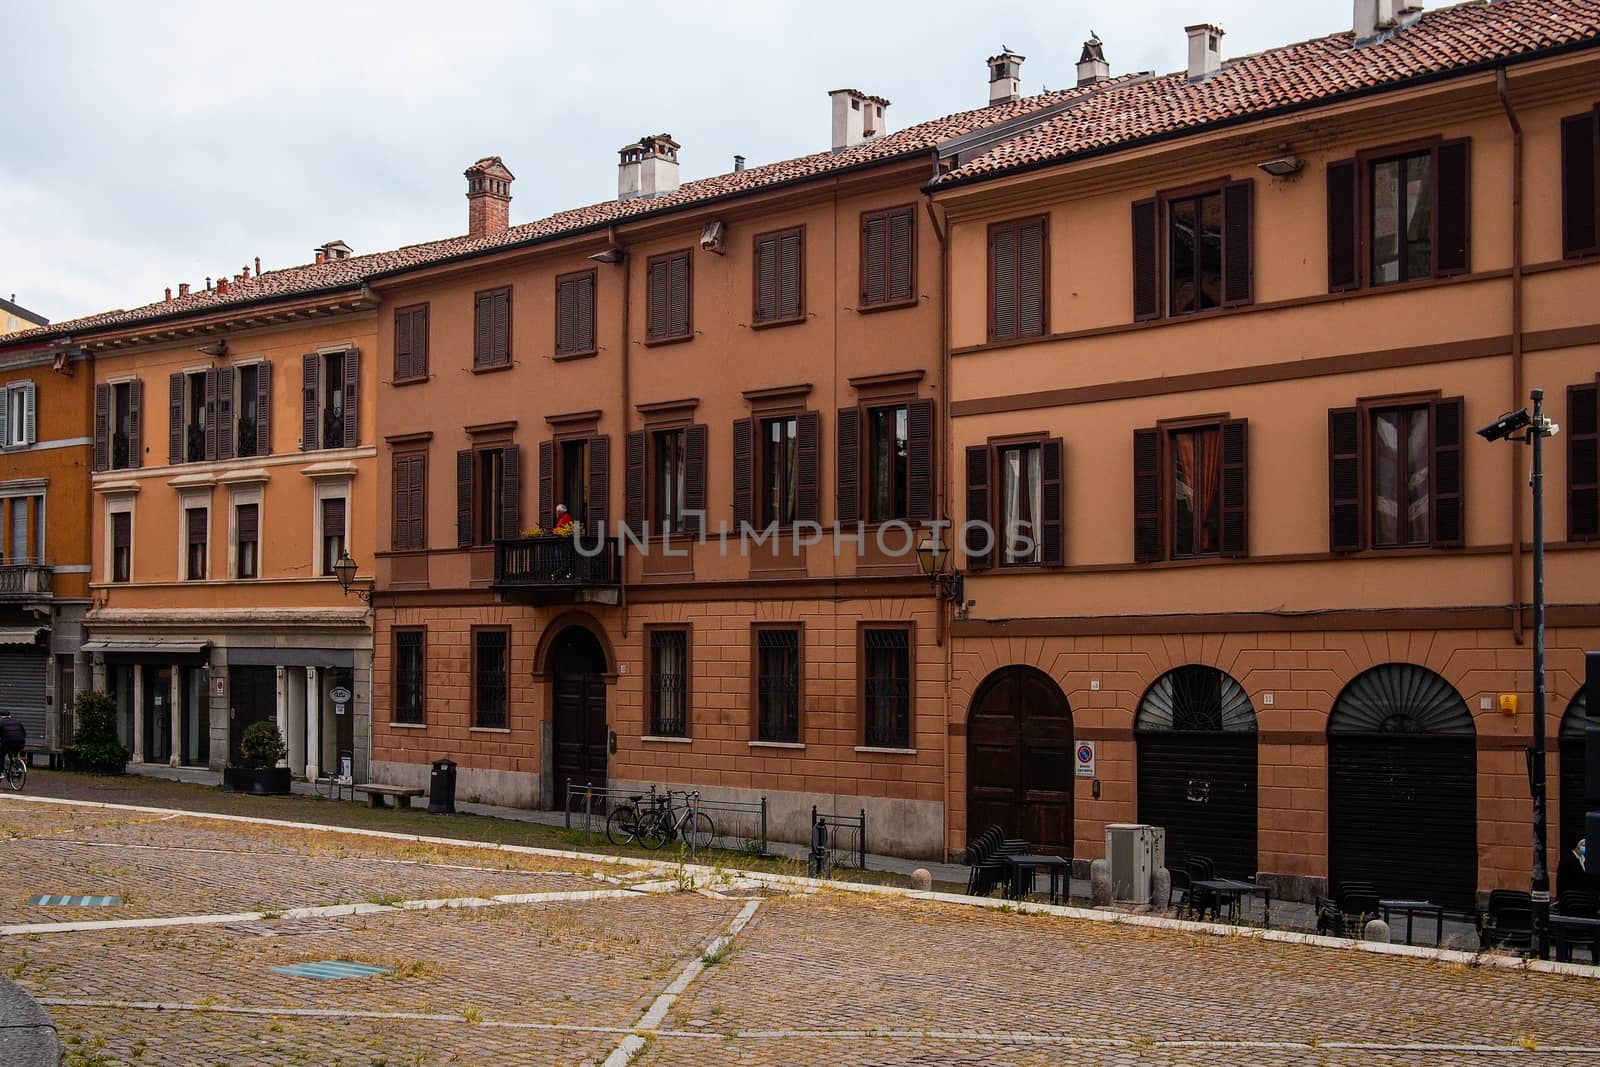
[546,625,610,806]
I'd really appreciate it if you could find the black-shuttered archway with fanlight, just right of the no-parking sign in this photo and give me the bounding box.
[1133,664,1256,878]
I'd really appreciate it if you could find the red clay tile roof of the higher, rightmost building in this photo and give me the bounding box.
[941,0,1600,184]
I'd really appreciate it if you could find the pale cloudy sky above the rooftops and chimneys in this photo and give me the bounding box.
[0,0,1350,320]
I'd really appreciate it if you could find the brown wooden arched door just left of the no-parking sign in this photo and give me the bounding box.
[966,665,1072,857]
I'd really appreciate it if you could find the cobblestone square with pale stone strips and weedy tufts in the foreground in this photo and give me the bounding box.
[0,798,1600,1067]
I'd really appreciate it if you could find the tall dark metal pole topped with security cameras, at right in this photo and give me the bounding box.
[1478,389,1562,960]
